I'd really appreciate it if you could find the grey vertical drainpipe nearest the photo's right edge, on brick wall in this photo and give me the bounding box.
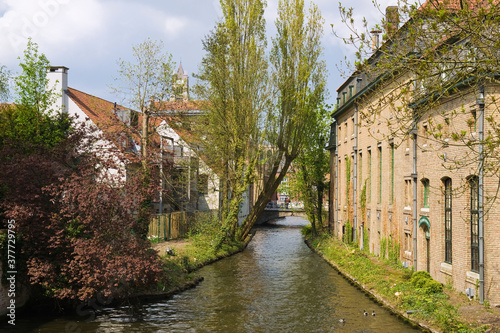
[477,85,484,304]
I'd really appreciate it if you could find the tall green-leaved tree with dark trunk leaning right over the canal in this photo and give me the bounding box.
[241,0,326,237]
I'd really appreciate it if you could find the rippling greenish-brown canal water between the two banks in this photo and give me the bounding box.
[8,217,419,333]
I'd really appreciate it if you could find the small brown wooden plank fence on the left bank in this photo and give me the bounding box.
[148,212,192,240]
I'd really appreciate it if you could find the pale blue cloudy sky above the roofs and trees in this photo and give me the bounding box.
[0,0,397,104]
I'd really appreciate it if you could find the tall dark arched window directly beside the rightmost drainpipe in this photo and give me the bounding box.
[469,176,479,272]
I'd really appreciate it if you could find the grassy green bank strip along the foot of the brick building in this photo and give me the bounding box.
[303,232,498,332]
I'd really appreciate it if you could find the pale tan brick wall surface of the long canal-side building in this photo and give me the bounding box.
[330,81,500,305]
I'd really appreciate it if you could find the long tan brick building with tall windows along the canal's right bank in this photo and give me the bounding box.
[328,3,500,305]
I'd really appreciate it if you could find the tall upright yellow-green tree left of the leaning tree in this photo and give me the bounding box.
[196,0,269,238]
